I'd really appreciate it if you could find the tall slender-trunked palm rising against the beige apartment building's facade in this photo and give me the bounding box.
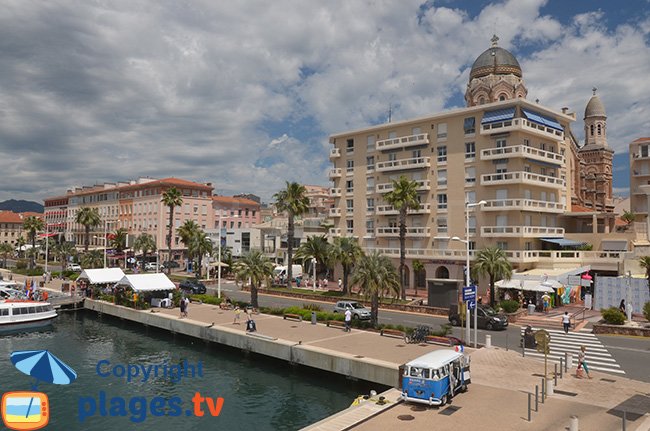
[384,175,420,299]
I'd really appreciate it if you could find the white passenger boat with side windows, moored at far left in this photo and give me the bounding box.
[0,282,57,333]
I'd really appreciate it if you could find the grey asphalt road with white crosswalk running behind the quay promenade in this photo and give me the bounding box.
[208,281,650,383]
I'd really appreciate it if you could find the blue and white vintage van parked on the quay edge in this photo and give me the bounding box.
[402,349,471,406]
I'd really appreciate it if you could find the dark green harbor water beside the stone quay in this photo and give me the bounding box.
[0,311,384,431]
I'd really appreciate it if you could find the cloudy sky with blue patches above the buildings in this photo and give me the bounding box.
[0,0,650,202]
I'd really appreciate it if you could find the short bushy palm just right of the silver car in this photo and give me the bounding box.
[352,252,401,326]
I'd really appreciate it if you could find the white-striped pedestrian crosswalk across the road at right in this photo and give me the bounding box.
[521,328,625,374]
